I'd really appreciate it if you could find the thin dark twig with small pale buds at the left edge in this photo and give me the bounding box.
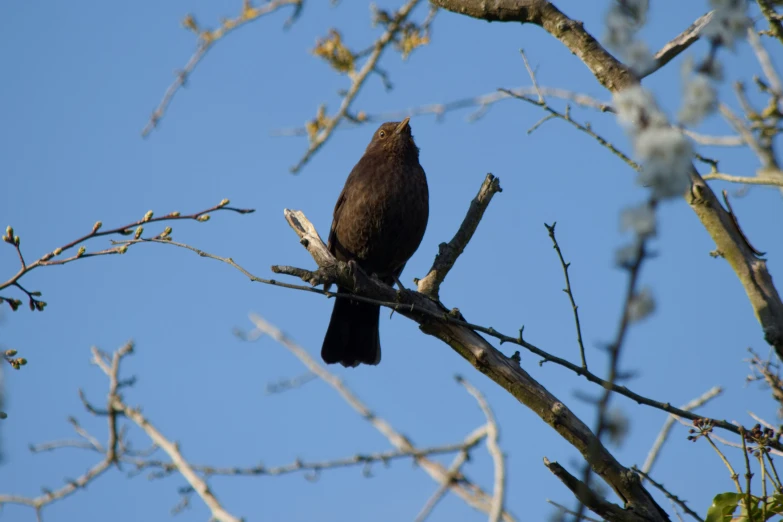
[0,199,254,311]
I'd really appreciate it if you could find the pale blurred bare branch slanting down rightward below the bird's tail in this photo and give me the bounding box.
[250,314,515,522]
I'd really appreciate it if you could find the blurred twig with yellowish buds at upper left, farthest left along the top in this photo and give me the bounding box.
[141,0,303,138]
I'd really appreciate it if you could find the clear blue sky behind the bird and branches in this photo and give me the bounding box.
[0,0,783,522]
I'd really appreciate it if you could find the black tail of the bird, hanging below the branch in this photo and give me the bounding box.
[321,287,381,368]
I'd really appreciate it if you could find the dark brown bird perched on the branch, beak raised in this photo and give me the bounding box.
[321,118,429,367]
